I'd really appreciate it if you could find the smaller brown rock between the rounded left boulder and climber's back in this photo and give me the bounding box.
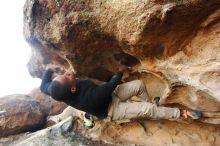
[29,88,67,115]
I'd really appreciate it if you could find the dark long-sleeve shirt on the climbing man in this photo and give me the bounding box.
[40,69,123,119]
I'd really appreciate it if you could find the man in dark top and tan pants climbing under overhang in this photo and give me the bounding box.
[40,67,201,128]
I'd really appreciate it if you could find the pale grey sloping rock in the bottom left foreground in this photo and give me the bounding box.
[0,117,115,146]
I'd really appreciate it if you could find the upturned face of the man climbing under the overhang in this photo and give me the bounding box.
[53,72,76,87]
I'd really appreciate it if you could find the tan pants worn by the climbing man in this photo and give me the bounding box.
[108,80,180,121]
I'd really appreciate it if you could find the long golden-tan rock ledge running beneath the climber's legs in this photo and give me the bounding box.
[39,106,220,146]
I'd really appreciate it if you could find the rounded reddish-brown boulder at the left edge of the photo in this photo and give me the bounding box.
[0,94,46,136]
